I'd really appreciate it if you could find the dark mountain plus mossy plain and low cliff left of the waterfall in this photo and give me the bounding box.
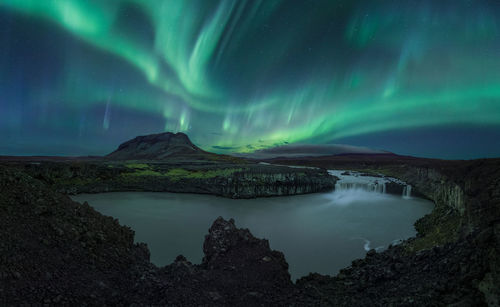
[0,132,336,198]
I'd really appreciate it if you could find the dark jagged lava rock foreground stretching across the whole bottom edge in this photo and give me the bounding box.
[0,160,500,306]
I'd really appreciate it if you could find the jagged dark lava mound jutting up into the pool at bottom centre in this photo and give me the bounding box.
[142,217,303,306]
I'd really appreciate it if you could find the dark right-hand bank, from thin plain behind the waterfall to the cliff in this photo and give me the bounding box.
[274,155,500,243]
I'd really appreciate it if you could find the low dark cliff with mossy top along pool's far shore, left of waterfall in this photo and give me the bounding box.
[13,162,335,198]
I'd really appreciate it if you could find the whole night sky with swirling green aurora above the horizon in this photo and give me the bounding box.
[0,0,500,158]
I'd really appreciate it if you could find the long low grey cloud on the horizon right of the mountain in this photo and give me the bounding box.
[236,144,390,159]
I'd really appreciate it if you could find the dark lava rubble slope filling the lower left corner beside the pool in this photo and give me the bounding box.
[0,168,152,306]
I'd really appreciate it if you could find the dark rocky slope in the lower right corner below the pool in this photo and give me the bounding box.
[297,228,500,306]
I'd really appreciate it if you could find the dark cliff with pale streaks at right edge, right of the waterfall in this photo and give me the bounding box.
[364,160,500,248]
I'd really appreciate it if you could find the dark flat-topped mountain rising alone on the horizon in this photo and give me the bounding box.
[106,132,208,160]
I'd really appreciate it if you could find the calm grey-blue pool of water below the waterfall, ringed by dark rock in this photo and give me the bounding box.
[73,190,434,279]
